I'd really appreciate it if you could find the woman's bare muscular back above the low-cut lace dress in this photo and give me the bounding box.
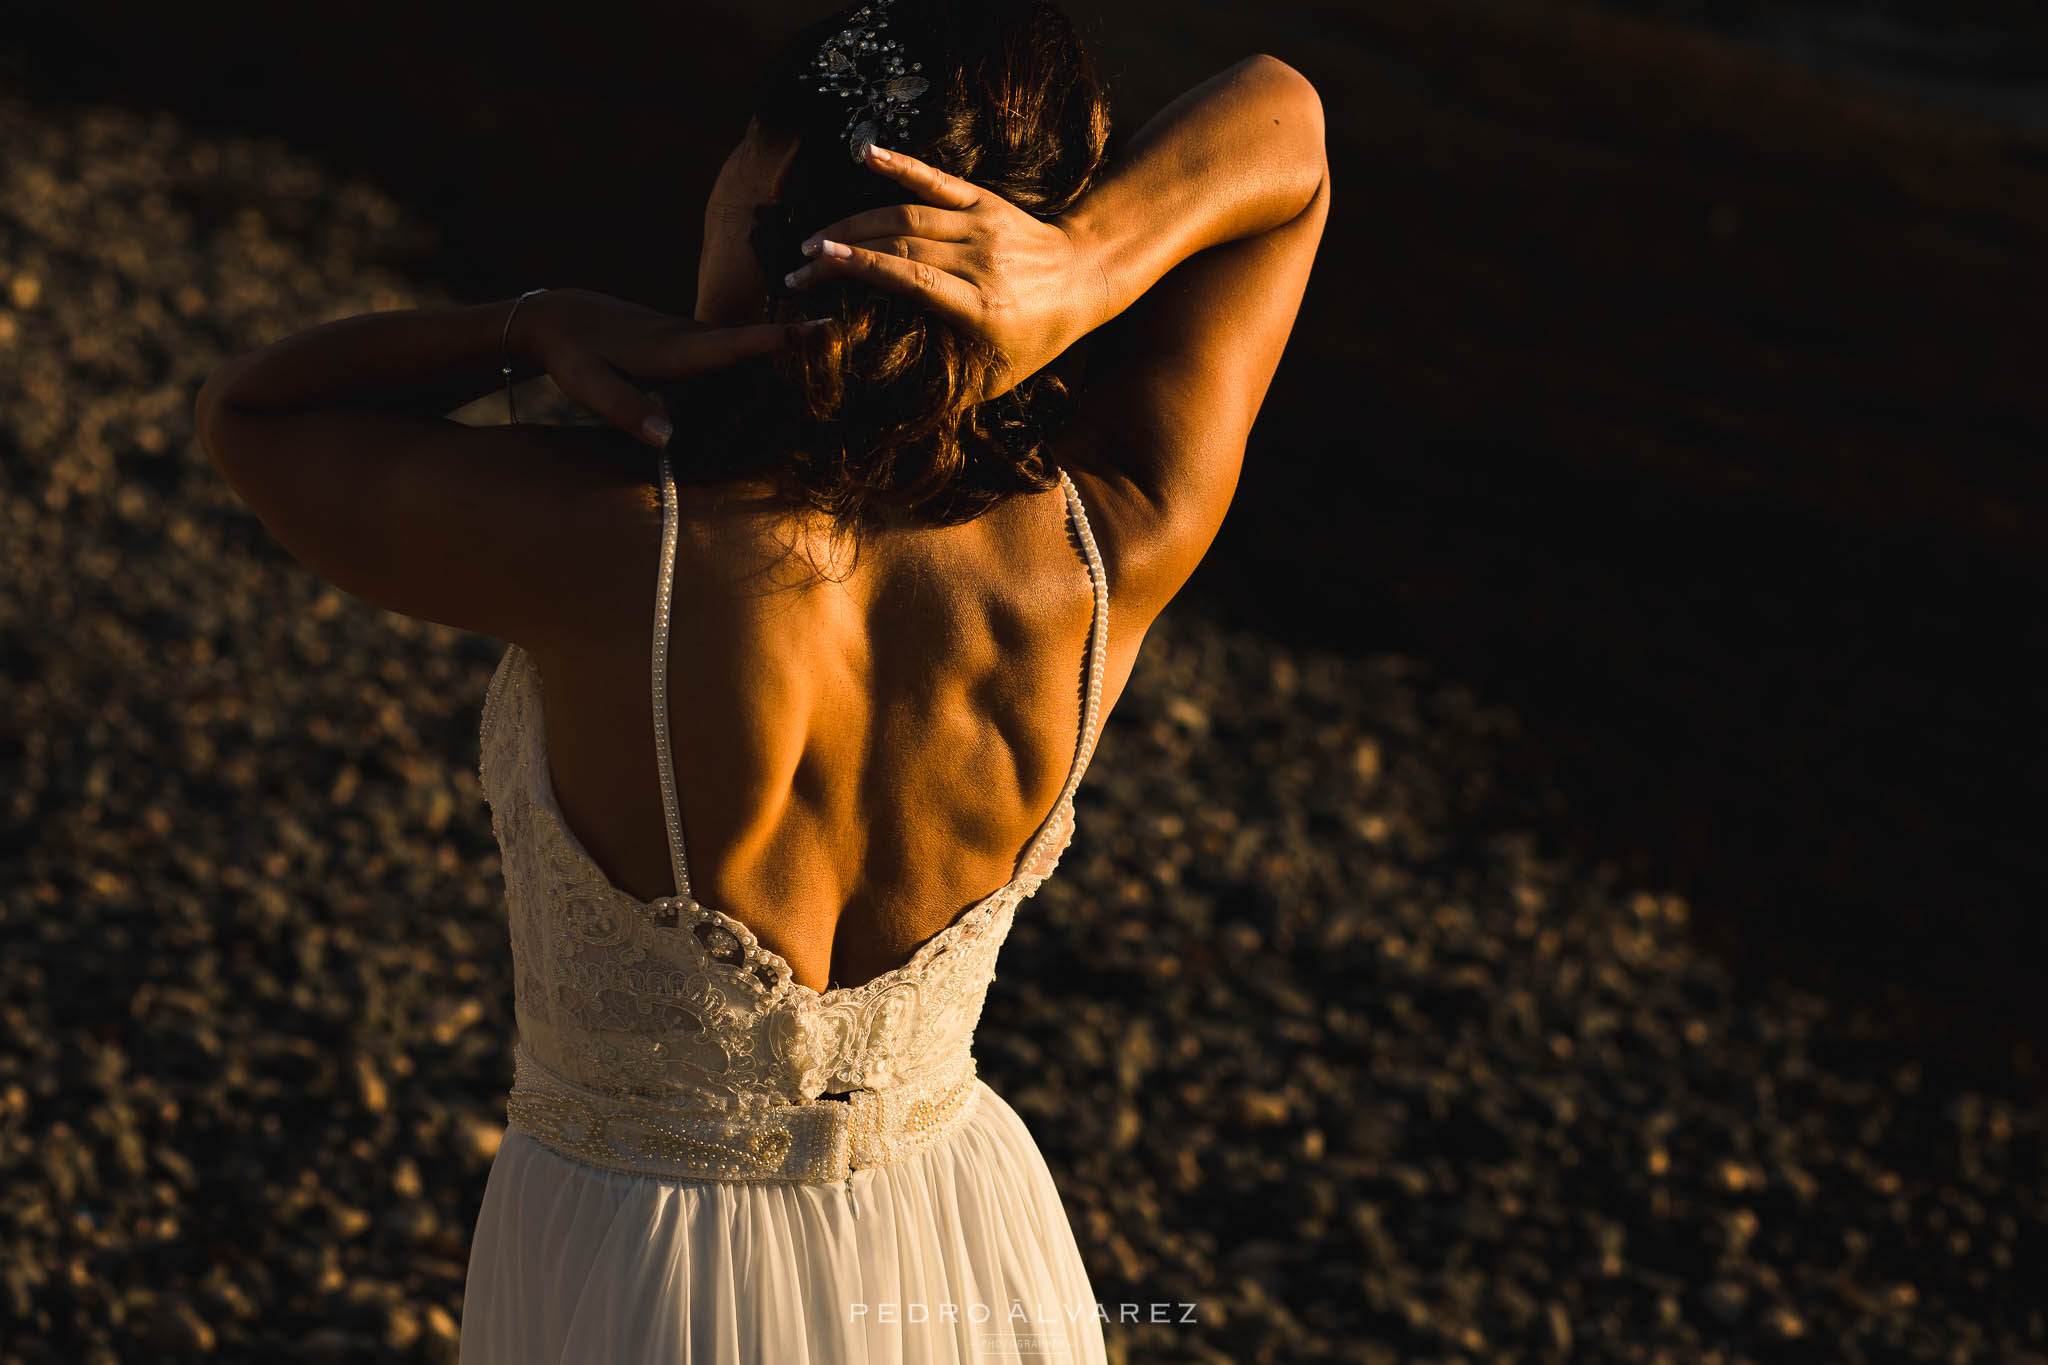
[520,462,1151,990]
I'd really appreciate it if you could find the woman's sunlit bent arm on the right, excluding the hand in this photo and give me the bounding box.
[1040,55,1329,620]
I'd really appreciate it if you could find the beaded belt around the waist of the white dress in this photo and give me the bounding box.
[506,1046,979,1183]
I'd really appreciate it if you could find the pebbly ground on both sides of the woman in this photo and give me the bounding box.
[0,80,2048,1365]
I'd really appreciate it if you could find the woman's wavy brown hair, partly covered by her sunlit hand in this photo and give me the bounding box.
[666,0,1110,556]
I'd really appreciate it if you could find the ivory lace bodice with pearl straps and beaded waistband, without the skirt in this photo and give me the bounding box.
[481,456,1108,1181]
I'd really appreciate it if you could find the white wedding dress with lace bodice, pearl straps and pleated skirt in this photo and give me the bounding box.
[461,458,1108,1365]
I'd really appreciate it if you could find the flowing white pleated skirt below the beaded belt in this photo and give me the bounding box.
[461,1081,1106,1365]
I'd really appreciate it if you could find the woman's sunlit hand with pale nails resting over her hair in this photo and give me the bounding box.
[788,147,1110,401]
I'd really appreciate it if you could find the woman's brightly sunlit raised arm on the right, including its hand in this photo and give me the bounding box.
[791,53,1329,620]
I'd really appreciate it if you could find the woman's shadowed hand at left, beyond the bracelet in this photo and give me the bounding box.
[506,289,797,450]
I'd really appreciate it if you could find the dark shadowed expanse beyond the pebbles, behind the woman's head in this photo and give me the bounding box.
[0,0,2048,1089]
